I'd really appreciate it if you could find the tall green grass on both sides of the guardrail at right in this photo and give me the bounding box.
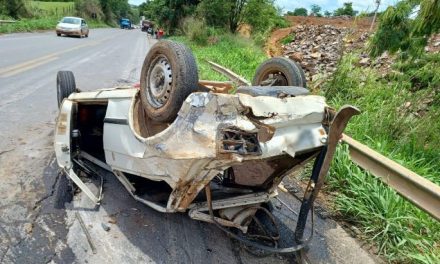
[324,54,440,263]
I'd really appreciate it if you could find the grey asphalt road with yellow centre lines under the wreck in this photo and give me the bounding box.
[0,29,374,263]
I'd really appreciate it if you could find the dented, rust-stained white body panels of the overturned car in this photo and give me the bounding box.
[55,88,327,212]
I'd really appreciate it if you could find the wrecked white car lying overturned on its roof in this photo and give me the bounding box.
[54,41,357,252]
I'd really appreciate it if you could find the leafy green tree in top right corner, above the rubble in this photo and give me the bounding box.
[369,0,440,57]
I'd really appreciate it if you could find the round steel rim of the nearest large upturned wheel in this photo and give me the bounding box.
[146,55,173,108]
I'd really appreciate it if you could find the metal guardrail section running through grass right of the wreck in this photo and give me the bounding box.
[342,135,440,220]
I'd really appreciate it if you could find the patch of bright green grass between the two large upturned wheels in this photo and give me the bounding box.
[171,34,267,81]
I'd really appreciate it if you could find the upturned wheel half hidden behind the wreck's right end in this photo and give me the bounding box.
[252,57,307,88]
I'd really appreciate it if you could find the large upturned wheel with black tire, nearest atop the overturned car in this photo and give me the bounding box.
[140,41,198,122]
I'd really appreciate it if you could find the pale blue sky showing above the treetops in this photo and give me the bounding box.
[128,0,398,12]
